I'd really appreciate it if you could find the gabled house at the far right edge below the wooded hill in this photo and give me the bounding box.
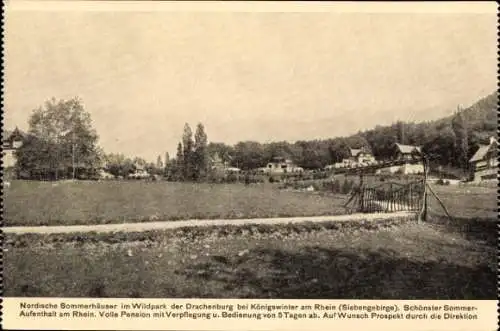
[469,137,498,181]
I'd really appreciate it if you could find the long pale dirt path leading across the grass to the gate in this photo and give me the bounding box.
[3,212,415,234]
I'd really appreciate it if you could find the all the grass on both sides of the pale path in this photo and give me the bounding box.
[3,182,497,299]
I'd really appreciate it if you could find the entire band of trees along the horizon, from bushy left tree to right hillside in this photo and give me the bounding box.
[10,92,498,181]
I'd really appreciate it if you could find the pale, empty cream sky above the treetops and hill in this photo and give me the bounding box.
[4,1,497,161]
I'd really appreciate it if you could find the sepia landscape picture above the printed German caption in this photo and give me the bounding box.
[2,1,498,304]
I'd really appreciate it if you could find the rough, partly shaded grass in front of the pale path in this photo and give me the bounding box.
[4,220,496,299]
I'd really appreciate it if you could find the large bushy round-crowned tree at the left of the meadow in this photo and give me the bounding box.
[18,98,101,179]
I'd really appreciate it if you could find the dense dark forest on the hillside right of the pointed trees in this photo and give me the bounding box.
[208,92,498,170]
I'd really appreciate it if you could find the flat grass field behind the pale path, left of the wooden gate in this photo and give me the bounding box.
[4,181,346,226]
